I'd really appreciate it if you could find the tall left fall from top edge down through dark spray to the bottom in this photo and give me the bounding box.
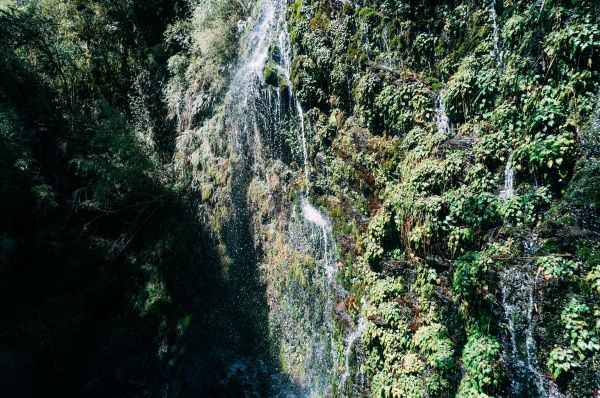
[216,0,302,397]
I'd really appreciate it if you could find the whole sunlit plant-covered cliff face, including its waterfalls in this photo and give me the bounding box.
[169,0,600,397]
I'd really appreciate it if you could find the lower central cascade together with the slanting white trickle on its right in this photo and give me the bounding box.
[278,198,366,398]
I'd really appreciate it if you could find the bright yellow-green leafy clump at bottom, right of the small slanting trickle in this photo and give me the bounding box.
[361,268,455,397]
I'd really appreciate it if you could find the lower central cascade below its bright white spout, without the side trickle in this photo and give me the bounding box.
[282,198,339,398]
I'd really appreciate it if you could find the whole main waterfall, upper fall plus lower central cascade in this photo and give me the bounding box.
[216,0,362,398]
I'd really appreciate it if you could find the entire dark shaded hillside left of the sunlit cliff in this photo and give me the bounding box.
[0,1,300,398]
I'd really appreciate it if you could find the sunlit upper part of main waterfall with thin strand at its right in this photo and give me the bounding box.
[224,0,309,173]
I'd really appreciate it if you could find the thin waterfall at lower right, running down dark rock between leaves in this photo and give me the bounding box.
[500,235,547,397]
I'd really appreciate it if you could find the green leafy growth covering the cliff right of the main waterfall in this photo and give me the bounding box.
[288,1,600,397]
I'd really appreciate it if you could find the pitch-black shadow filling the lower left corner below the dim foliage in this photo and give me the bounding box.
[0,180,300,397]
